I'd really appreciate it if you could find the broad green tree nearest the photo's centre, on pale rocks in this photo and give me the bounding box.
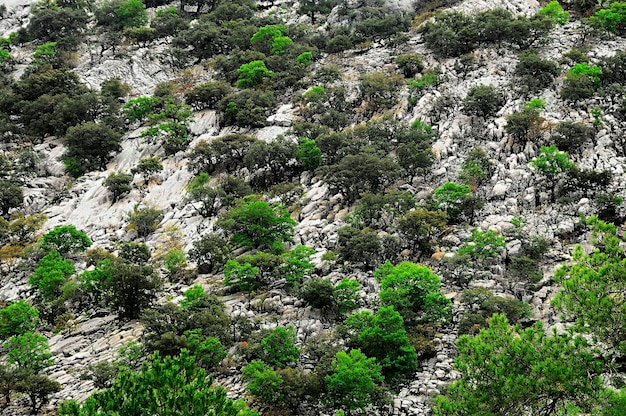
[218,197,297,248]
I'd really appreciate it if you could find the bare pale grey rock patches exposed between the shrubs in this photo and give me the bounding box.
[0,0,626,415]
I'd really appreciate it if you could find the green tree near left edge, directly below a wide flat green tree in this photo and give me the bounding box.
[28,251,76,300]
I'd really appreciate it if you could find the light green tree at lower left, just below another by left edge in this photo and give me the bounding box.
[4,332,54,374]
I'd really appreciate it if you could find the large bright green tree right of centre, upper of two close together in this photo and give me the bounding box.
[374,261,452,323]
